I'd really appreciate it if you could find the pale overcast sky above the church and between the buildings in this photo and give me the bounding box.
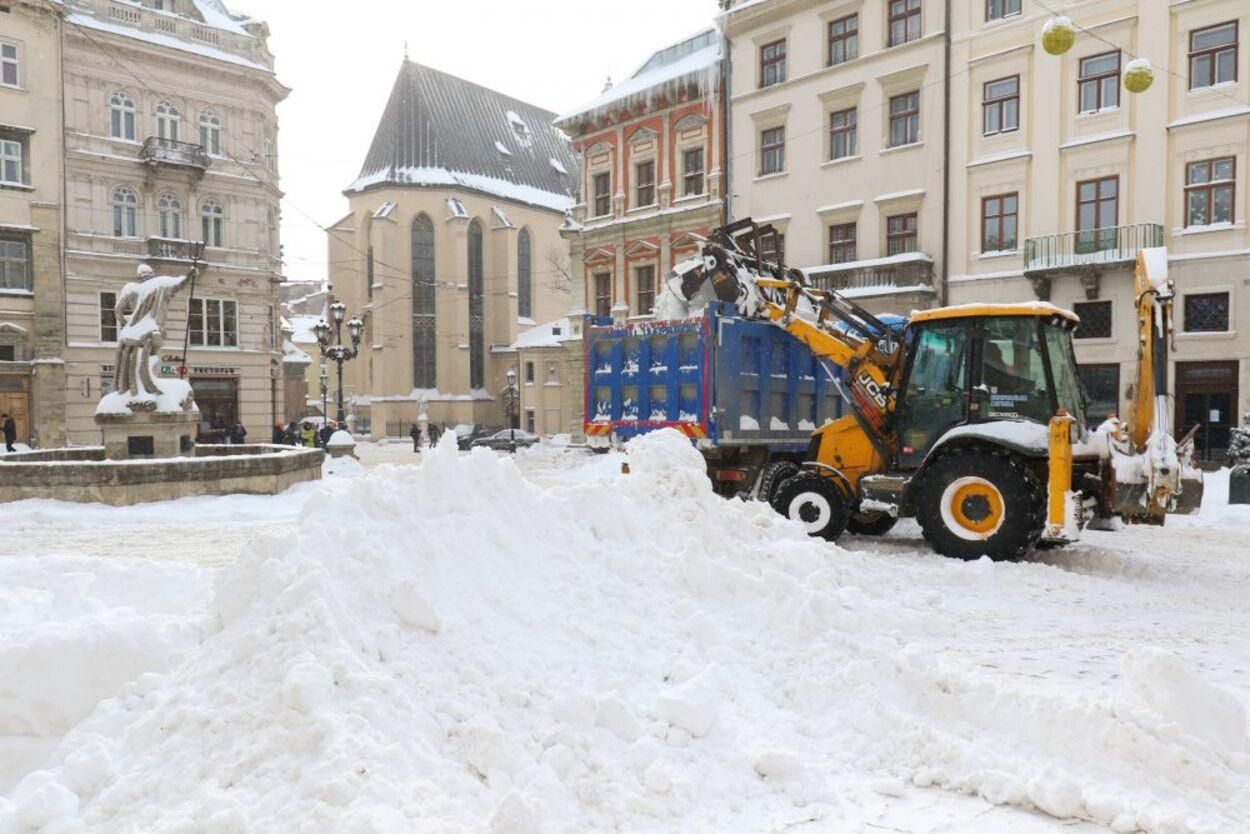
[226,0,718,287]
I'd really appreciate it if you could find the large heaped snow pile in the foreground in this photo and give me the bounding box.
[0,430,1250,834]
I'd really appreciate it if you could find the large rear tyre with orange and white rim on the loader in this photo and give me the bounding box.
[916,448,1046,561]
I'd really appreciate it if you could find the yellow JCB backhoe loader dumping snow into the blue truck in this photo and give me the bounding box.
[671,219,1203,559]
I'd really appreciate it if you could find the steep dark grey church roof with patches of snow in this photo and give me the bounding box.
[348,61,579,211]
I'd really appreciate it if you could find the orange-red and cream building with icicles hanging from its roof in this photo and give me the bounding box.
[555,30,725,321]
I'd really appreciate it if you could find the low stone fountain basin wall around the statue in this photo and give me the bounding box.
[0,444,325,506]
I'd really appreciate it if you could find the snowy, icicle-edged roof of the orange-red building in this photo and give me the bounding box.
[556,29,723,125]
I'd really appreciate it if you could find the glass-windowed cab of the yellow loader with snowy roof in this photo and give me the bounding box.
[895,305,1085,469]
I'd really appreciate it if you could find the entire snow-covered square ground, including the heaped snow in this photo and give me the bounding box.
[0,433,1250,834]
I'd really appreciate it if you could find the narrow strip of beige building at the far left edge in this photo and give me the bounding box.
[0,0,65,445]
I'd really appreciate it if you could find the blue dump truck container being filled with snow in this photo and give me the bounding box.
[585,301,844,493]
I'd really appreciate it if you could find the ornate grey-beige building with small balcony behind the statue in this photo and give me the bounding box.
[64,0,288,443]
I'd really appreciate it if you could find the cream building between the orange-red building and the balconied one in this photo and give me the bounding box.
[720,0,940,314]
